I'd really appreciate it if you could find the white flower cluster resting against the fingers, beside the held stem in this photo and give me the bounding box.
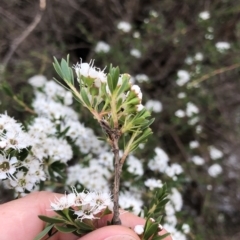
[51,189,113,221]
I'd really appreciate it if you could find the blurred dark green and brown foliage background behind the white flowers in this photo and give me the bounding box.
[0,0,240,240]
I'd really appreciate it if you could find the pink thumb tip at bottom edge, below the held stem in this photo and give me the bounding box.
[79,225,140,240]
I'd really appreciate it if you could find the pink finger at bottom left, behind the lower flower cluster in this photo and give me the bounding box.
[0,192,77,240]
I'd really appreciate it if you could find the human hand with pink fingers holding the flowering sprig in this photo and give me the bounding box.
[0,192,172,240]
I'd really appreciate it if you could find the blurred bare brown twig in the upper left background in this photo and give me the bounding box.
[2,0,46,71]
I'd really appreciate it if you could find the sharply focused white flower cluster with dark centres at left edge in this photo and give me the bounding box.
[0,114,46,193]
